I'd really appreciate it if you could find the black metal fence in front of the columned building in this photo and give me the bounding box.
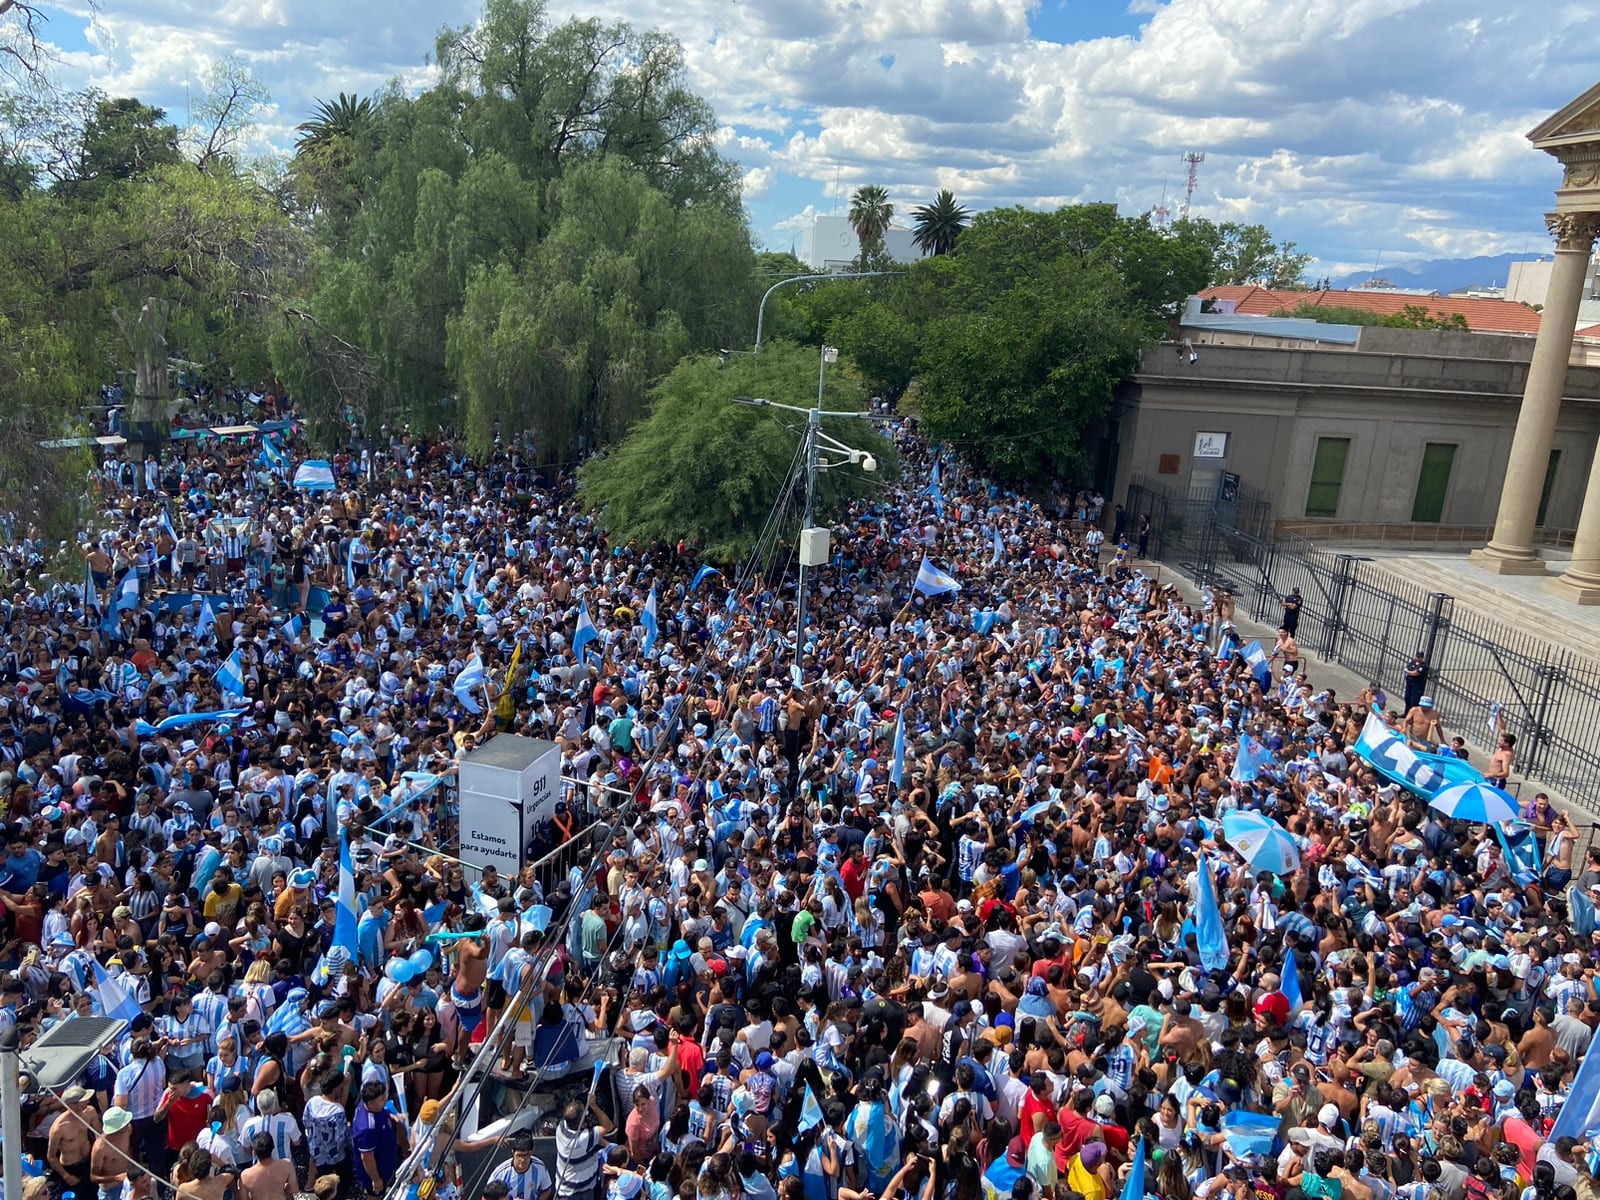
[1123,480,1600,811]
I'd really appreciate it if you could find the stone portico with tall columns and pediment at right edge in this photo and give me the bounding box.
[1472,85,1600,605]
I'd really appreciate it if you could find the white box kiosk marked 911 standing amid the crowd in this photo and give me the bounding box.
[458,733,562,878]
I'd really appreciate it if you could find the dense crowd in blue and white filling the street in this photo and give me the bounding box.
[0,404,1600,1200]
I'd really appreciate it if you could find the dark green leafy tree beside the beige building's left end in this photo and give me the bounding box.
[771,205,1213,482]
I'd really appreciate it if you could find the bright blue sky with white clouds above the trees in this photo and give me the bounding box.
[21,0,1600,274]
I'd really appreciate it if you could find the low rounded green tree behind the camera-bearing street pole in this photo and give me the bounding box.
[579,342,894,562]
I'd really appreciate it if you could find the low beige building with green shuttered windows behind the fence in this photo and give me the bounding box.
[1112,326,1600,544]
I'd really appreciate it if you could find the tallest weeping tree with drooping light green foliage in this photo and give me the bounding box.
[274,0,760,462]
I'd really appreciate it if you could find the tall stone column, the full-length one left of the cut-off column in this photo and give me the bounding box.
[1472,213,1600,574]
